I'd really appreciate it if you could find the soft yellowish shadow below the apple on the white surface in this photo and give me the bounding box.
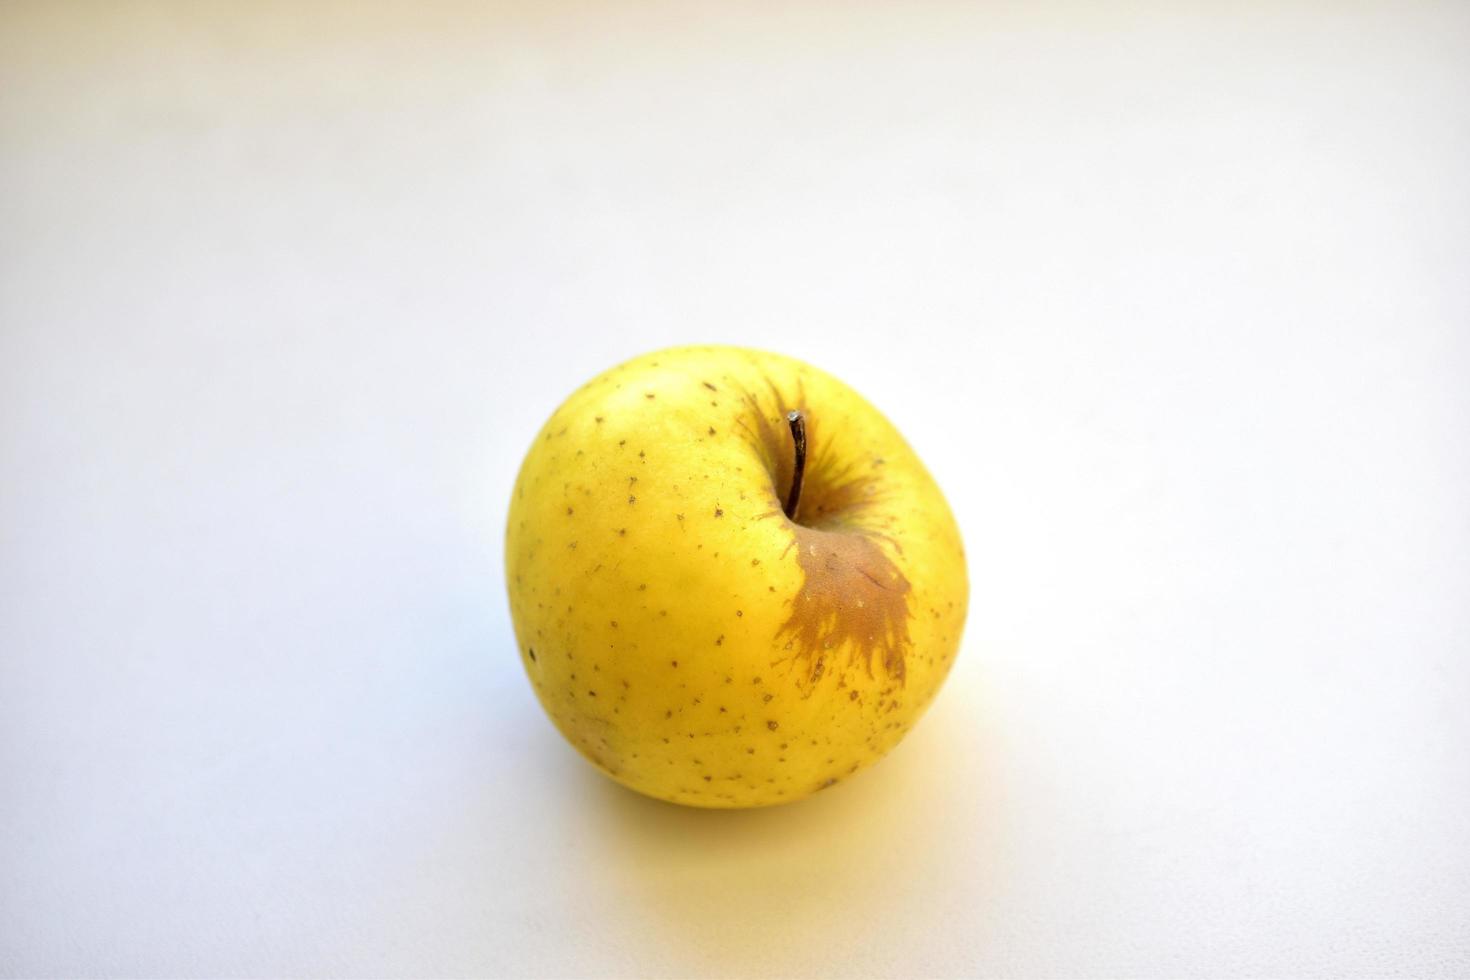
[570,713,976,976]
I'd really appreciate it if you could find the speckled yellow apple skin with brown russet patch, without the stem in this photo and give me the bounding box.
[506,347,969,807]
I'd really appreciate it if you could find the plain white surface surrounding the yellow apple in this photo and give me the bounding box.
[0,0,1470,977]
